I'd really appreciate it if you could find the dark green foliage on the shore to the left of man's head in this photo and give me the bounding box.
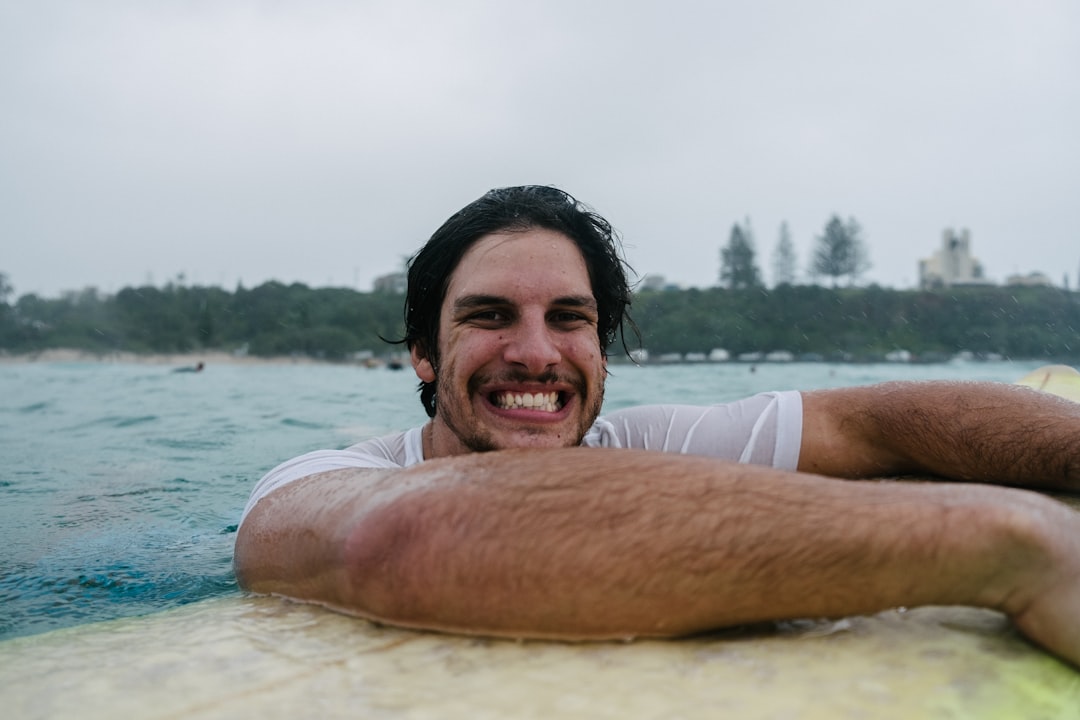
[0,282,403,359]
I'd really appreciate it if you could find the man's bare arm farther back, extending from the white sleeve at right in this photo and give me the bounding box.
[799,382,1080,492]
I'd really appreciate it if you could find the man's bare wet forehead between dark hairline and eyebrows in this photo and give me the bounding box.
[446,228,593,303]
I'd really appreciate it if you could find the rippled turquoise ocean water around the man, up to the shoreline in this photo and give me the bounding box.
[0,362,1054,639]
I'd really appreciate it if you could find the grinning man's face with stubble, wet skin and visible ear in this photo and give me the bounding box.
[413,228,607,458]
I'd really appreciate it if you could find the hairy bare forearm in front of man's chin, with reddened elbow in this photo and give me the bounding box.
[235,448,1080,663]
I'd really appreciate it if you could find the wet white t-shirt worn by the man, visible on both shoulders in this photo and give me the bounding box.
[240,391,802,522]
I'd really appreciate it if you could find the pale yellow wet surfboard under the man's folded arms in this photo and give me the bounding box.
[0,366,1080,720]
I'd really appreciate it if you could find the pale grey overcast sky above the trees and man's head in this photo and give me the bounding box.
[0,0,1080,297]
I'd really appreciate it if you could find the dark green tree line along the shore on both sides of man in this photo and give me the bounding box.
[0,274,1080,362]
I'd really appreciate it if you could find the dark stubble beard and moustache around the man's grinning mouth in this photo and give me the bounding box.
[435,372,605,452]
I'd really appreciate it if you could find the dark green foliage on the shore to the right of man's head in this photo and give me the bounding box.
[633,285,1080,361]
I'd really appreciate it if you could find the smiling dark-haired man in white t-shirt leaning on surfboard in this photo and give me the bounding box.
[235,187,1080,664]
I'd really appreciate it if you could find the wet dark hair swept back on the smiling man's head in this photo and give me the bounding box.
[399,185,640,418]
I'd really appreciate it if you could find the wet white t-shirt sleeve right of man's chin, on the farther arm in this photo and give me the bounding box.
[584,391,802,470]
